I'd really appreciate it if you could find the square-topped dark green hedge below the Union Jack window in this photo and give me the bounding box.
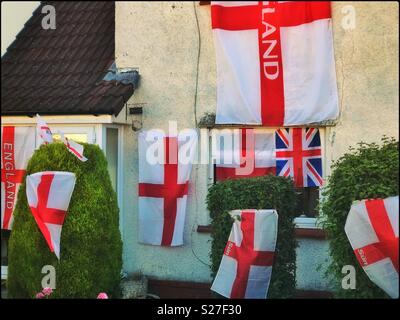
[207,175,297,298]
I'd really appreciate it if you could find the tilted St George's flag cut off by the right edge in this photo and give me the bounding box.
[344,196,399,298]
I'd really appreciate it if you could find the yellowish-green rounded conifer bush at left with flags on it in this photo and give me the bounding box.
[7,143,122,298]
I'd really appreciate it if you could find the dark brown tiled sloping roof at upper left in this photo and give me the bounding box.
[1,1,138,115]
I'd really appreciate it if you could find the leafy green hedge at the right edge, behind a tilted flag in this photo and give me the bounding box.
[321,138,399,298]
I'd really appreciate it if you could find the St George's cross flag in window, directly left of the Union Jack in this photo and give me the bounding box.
[211,128,275,181]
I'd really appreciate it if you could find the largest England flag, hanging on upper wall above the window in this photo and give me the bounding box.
[211,1,339,127]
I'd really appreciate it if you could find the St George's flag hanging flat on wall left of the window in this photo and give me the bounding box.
[138,130,197,246]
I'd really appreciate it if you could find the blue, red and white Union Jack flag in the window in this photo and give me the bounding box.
[275,128,323,187]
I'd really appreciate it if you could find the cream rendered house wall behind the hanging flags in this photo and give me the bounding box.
[115,2,399,290]
